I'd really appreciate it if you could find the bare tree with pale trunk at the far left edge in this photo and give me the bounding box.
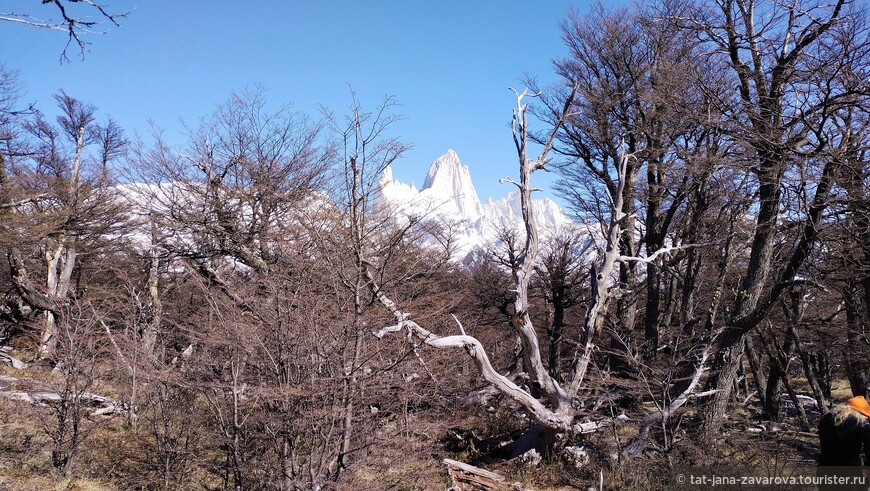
[3,92,126,357]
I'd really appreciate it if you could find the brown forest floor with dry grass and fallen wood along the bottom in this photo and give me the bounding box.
[0,364,849,491]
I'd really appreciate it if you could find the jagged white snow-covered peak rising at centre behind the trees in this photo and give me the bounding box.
[375,150,574,260]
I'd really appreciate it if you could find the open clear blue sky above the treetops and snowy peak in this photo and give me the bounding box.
[0,0,612,200]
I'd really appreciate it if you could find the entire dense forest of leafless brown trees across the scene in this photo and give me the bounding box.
[0,0,870,491]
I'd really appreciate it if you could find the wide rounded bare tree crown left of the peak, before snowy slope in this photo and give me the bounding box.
[130,88,331,309]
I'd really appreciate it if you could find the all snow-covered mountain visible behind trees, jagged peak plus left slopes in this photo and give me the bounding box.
[116,150,589,262]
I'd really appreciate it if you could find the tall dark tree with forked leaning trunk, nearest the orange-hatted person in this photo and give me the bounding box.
[674,0,860,434]
